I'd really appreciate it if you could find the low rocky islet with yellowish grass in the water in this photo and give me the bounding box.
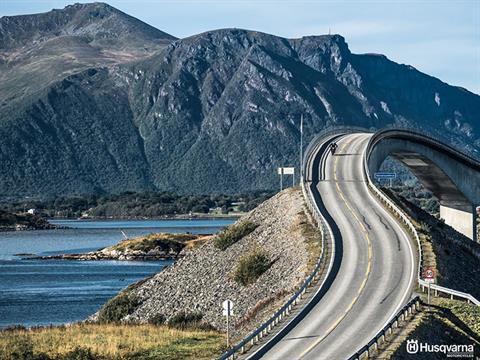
[32,233,211,261]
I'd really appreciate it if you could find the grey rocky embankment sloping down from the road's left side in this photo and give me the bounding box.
[94,189,320,336]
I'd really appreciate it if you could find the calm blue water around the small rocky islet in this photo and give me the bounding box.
[0,219,233,328]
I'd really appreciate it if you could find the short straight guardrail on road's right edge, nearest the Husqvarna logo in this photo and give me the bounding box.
[348,296,422,360]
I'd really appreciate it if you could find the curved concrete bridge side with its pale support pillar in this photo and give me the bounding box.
[365,129,480,240]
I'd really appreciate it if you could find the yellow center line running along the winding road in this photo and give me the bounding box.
[300,139,372,359]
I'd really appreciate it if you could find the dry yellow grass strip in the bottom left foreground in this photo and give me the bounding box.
[0,324,224,360]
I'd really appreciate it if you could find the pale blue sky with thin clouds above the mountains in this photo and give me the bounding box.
[0,0,480,94]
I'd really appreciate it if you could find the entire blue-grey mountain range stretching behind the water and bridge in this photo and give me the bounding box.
[0,3,480,200]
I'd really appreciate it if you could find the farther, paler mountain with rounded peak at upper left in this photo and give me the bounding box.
[0,3,176,106]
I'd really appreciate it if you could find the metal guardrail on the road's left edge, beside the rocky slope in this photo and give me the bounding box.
[219,167,333,360]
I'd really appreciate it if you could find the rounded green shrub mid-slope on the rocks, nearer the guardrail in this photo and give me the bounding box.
[233,249,272,286]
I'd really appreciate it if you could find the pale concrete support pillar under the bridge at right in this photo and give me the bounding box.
[440,203,477,241]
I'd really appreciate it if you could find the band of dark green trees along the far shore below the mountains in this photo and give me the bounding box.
[0,191,274,218]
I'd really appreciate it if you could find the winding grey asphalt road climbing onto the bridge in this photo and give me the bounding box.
[262,134,415,360]
